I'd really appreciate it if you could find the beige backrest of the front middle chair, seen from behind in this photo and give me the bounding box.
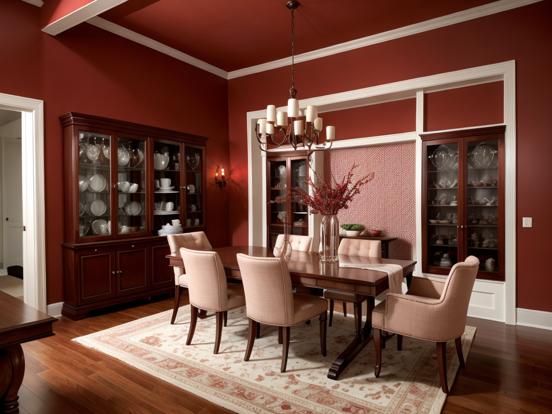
[237,253,294,326]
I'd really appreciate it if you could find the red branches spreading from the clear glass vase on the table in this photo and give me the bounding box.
[294,164,374,215]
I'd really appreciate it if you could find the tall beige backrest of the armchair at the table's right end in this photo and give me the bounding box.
[441,256,479,335]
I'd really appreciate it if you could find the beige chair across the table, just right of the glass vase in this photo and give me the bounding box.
[324,239,381,332]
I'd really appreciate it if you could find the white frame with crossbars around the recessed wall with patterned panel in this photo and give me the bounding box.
[246,60,516,325]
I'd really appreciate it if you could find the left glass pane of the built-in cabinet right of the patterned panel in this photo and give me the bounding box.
[425,143,459,268]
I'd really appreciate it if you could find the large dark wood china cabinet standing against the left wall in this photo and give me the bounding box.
[61,113,206,319]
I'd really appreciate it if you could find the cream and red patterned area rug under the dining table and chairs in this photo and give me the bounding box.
[74,306,475,414]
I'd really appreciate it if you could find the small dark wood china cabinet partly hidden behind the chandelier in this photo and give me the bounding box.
[266,153,309,249]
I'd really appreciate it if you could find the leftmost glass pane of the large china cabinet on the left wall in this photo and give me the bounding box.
[79,132,111,237]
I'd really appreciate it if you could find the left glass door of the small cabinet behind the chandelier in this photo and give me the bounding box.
[268,159,289,248]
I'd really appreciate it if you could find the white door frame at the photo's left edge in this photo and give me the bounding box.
[0,93,46,312]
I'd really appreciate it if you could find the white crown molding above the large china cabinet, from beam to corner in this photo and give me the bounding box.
[87,17,228,79]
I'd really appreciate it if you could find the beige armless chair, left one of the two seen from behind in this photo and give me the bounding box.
[180,247,245,354]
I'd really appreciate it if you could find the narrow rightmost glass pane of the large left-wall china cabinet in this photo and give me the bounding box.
[185,146,204,227]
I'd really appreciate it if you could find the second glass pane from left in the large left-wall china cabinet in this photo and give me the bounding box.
[117,138,146,234]
